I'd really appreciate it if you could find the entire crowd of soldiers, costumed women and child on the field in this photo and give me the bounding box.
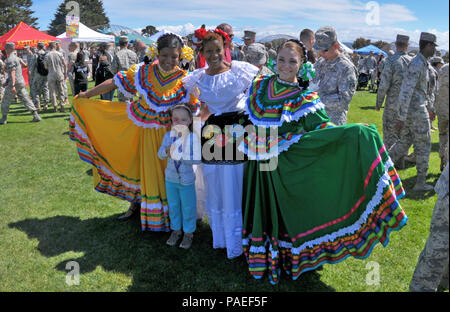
[0,23,448,291]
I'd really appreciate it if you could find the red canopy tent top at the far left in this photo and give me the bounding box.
[0,22,57,50]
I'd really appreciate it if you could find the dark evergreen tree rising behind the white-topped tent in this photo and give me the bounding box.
[48,0,109,36]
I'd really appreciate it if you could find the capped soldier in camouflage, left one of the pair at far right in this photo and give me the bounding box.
[376,35,411,150]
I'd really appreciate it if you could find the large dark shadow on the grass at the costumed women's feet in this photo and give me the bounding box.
[9,215,334,292]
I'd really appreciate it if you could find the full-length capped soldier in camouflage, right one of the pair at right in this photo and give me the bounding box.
[389,32,436,191]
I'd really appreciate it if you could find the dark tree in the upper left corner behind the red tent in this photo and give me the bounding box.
[0,0,37,36]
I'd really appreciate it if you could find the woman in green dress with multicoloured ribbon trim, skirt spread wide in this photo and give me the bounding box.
[239,40,407,283]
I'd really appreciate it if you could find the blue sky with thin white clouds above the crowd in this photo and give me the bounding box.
[32,0,449,50]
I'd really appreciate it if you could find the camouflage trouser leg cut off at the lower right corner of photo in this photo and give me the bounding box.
[409,162,449,292]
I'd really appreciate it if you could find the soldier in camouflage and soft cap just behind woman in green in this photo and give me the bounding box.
[313,26,357,125]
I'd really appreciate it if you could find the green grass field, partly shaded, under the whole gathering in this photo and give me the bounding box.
[0,83,440,292]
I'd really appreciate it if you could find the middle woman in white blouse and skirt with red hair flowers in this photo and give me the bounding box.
[183,29,258,259]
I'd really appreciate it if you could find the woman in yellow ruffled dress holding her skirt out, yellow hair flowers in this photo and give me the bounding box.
[70,34,200,231]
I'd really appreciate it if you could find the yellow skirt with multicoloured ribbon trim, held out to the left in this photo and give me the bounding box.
[70,97,170,231]
